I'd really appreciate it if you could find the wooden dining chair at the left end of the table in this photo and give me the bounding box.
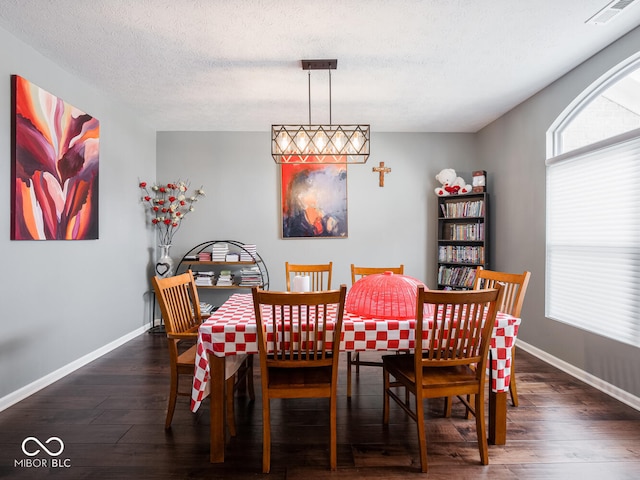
[151,270,255,436]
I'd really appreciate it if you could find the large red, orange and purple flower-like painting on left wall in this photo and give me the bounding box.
[11,75,100,240]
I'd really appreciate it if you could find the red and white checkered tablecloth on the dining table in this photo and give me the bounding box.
[191,293,520,412]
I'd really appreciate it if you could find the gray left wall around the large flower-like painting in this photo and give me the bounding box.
[0,29,155,402]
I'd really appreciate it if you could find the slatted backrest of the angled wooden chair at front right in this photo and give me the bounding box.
[415,285,501,376]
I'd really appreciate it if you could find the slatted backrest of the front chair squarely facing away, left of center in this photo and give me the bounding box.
[252,285,347,372]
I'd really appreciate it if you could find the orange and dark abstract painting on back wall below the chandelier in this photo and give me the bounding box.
[281,164,348,238]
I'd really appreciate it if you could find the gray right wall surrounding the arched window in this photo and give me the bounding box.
[477,29,640,397]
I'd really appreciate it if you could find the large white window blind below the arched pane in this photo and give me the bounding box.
[545,138,640,346]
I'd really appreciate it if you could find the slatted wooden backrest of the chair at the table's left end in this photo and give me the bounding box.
[151,270,202,336]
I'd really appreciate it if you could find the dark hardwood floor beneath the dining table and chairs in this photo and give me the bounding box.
[0,334,640,480]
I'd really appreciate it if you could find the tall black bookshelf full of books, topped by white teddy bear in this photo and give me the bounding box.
[437,192,489,290]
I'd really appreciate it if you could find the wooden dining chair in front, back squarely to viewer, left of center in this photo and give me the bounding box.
[252,285,347,473]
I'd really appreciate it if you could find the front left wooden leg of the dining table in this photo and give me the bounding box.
[209,354,225,463]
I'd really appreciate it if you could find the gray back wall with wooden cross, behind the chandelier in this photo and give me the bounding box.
[157,126,476,298]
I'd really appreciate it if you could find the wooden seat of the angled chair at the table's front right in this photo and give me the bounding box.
[382,355,478,397]
